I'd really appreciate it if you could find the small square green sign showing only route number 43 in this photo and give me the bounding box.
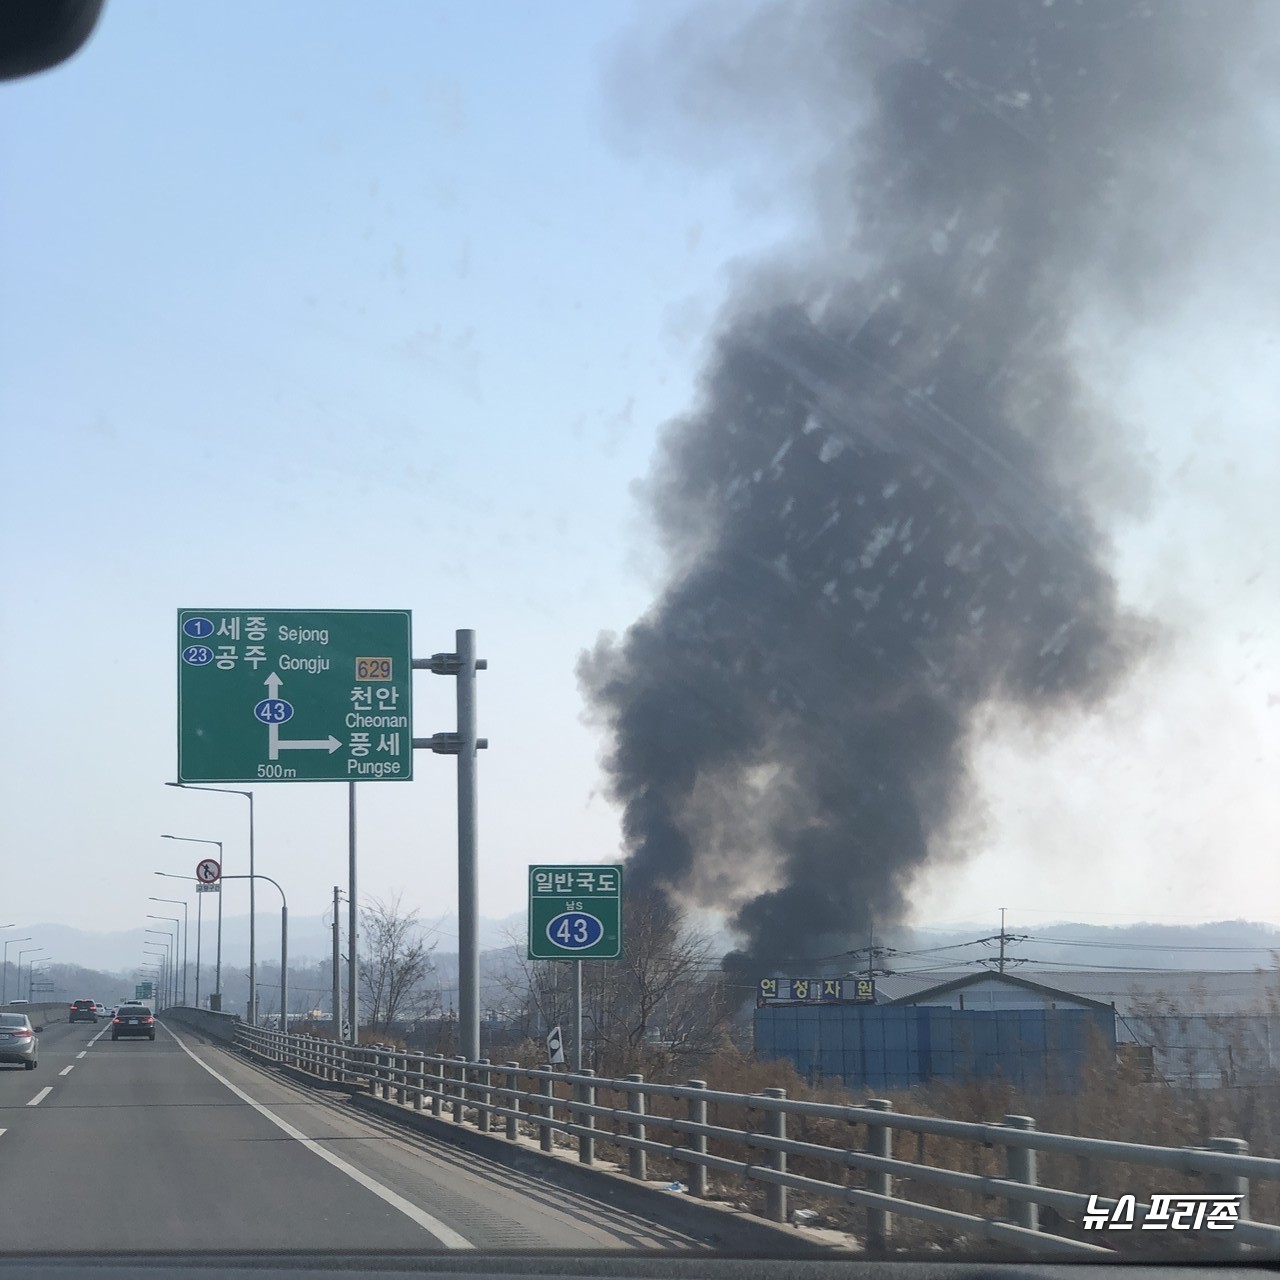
[529,865,622,960]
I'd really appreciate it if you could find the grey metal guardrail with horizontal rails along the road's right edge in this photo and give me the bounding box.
[234,1024,1280,1257]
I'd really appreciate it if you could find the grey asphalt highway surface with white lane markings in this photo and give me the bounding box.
[0,1023,698,1252]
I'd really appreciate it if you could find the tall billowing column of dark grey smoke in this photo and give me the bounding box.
[579,0,1269,972]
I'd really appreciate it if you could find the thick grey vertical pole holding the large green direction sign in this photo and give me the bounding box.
[457,630,480,1062]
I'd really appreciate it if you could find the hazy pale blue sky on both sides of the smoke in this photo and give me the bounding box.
[0,0,1280,952]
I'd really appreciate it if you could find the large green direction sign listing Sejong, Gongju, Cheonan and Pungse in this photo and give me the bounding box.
[178,609,413,782]
